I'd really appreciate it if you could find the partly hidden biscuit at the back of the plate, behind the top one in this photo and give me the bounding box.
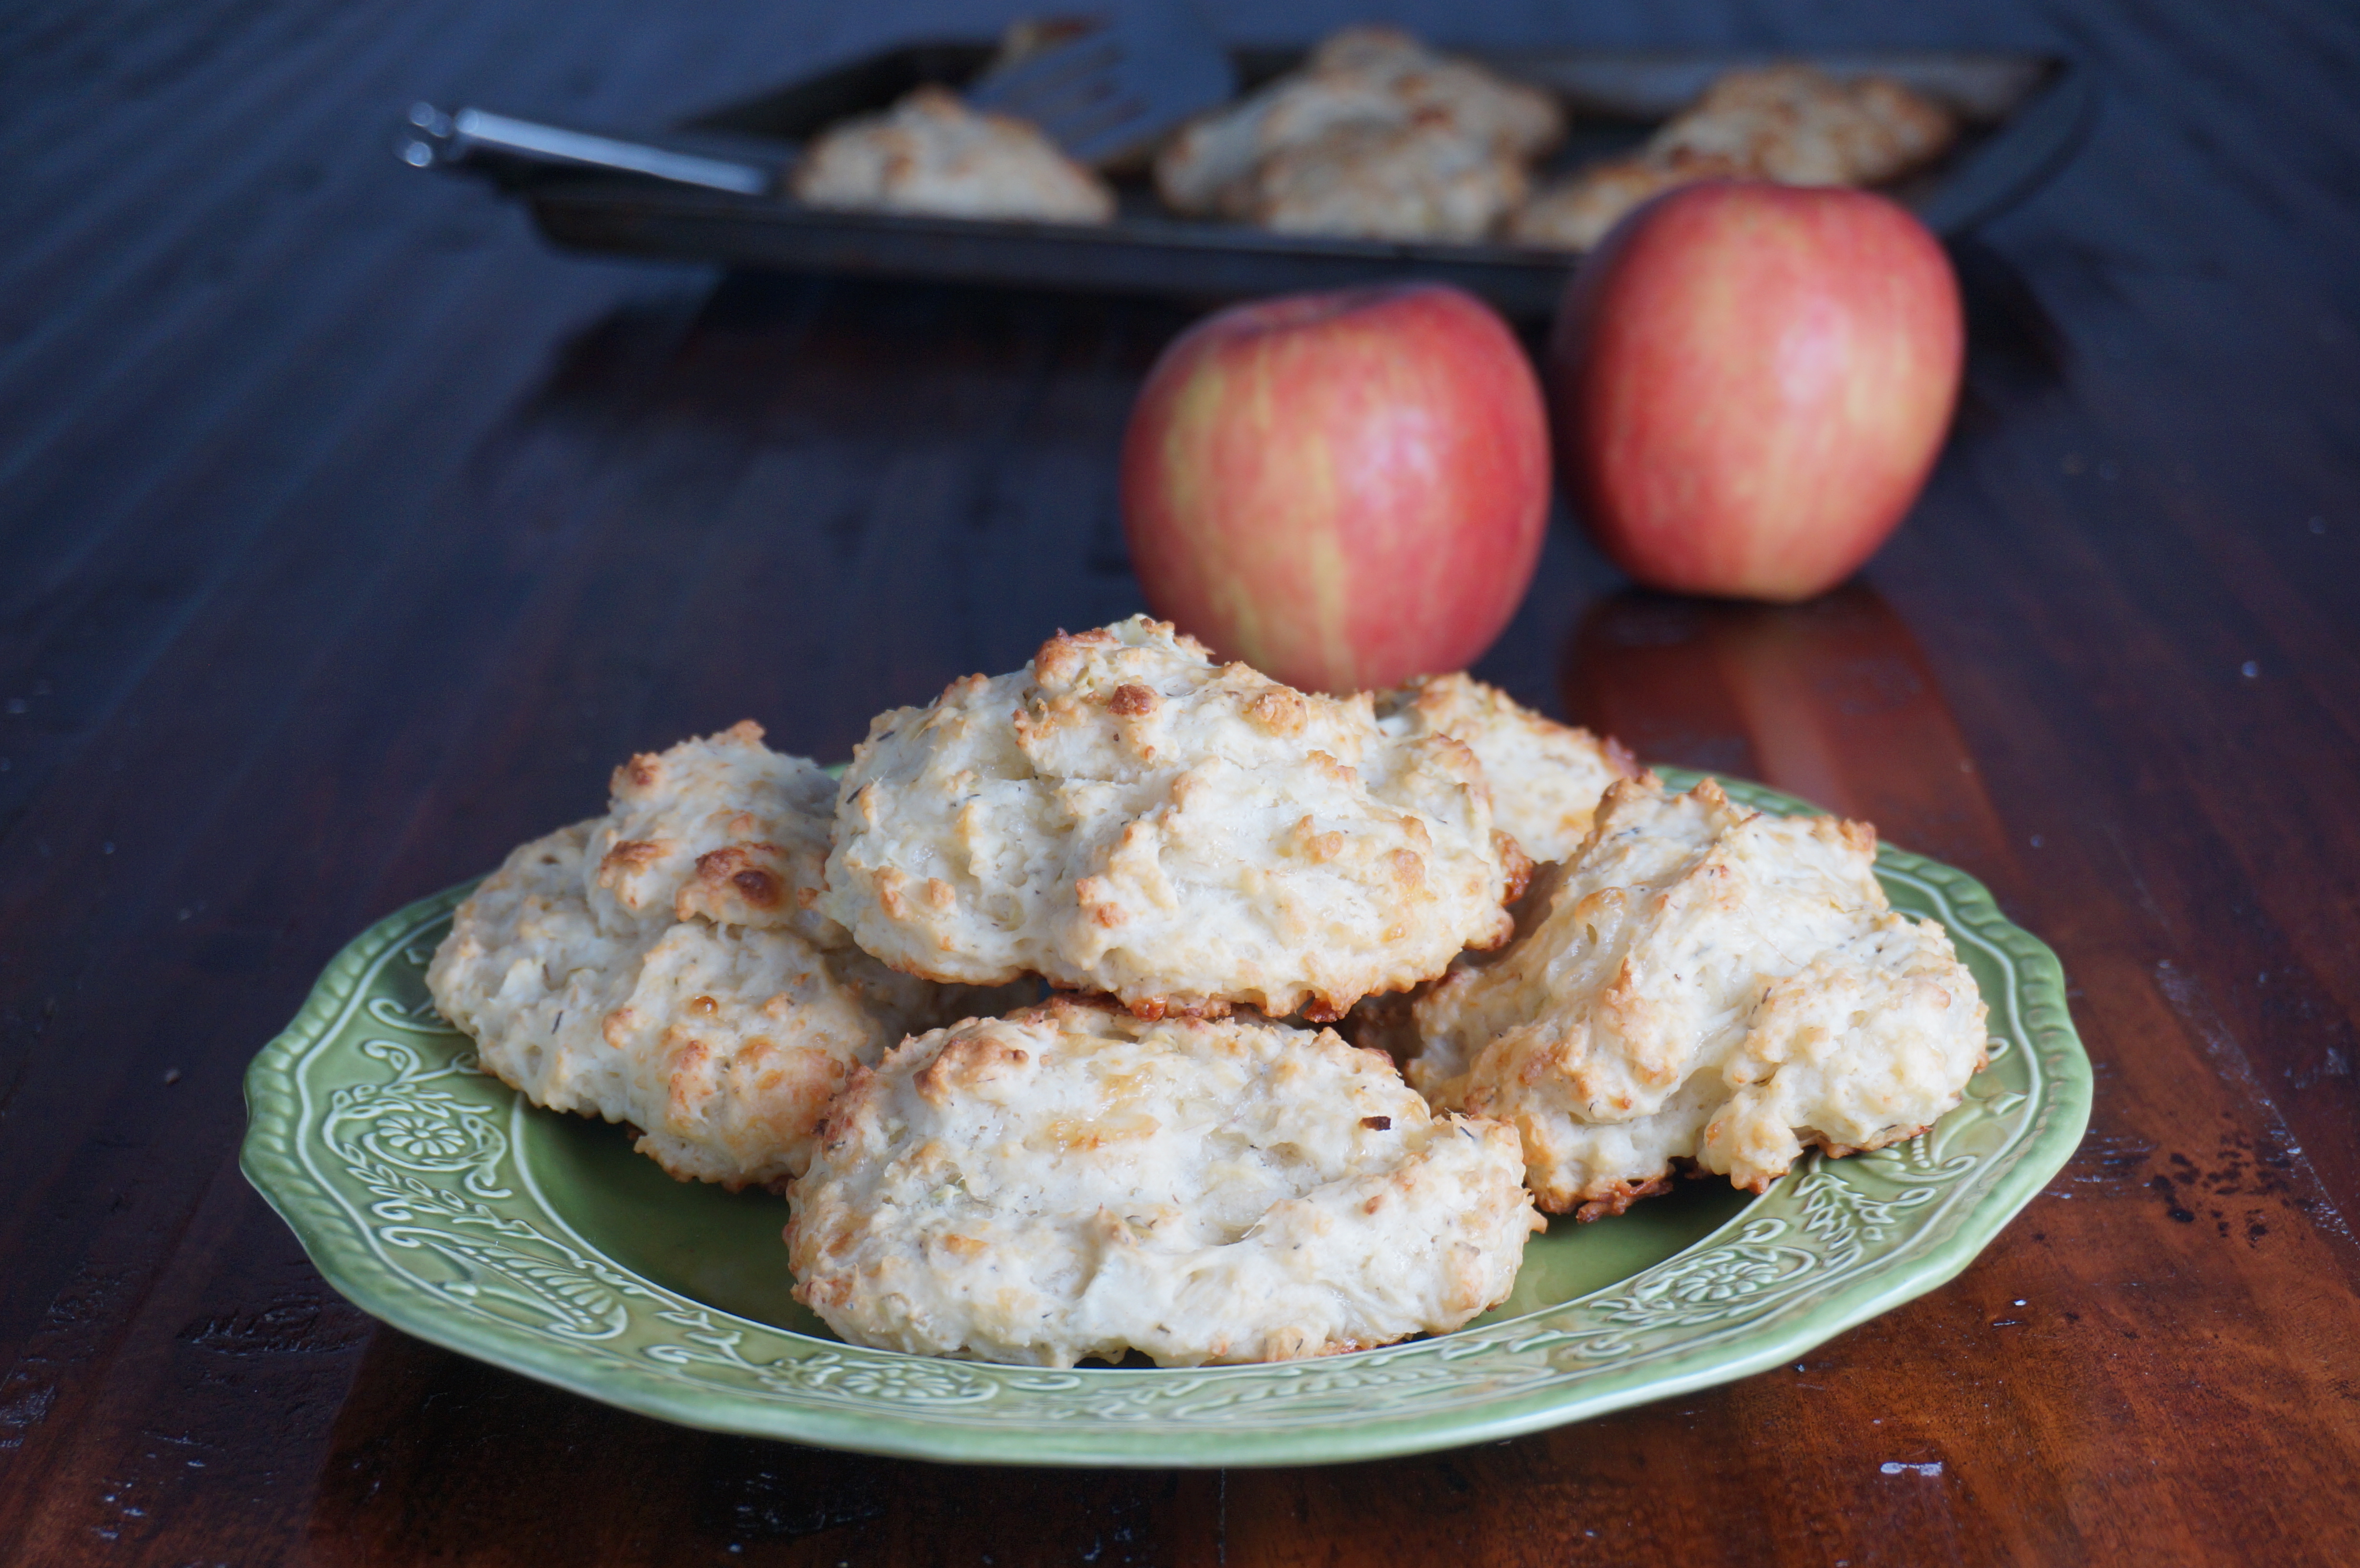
[1376,673,1638,862]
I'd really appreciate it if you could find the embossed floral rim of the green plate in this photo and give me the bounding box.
[241,768,2091,1467]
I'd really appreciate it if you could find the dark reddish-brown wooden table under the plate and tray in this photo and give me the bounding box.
[0,0,2360,1566]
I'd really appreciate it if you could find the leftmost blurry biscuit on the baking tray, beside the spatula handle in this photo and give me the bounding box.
[788,87,1114,224]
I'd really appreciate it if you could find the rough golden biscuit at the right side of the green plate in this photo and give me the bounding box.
[1409,774,1987,1218]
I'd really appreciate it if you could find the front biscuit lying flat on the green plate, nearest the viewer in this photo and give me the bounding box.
[786,999,1543,1367]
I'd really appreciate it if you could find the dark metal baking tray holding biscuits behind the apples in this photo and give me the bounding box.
[519,40,2093,317]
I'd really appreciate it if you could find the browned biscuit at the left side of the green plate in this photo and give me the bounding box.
[427,725,1015,1188]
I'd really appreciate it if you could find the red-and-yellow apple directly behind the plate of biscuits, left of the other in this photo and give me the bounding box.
[1123,283,1548,692]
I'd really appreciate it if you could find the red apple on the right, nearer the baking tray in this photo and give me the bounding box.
[1548,182,1966,602]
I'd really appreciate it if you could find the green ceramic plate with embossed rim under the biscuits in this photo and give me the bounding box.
[243,770,2091,1464]
